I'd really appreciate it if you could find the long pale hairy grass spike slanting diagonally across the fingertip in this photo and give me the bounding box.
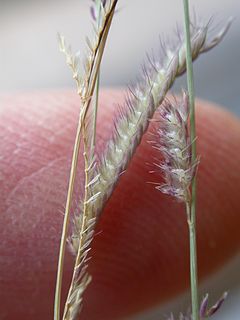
[70,23,230,251]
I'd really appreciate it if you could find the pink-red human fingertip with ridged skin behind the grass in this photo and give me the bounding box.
[0,90,240,320]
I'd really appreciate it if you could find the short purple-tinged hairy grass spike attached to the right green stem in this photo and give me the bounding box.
[152,92,198,203]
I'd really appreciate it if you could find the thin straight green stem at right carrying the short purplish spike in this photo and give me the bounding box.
[183,0,199,320]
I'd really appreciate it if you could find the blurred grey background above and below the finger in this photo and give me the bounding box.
[0,0,240,320]
